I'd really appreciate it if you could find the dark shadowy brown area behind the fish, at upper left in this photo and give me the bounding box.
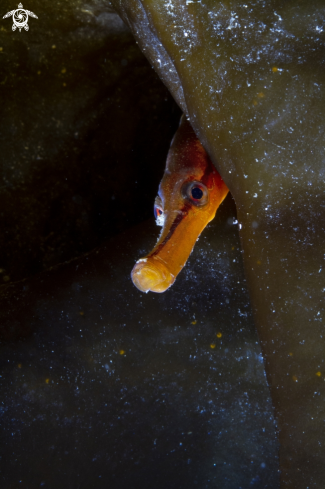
[0,0,180,284]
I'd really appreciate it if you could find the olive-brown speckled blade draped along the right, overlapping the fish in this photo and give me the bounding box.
[107,0,325,489]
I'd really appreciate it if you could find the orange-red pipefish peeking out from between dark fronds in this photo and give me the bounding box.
[131,116,228,292]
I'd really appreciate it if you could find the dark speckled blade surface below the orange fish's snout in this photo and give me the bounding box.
[0,195,279,489]
